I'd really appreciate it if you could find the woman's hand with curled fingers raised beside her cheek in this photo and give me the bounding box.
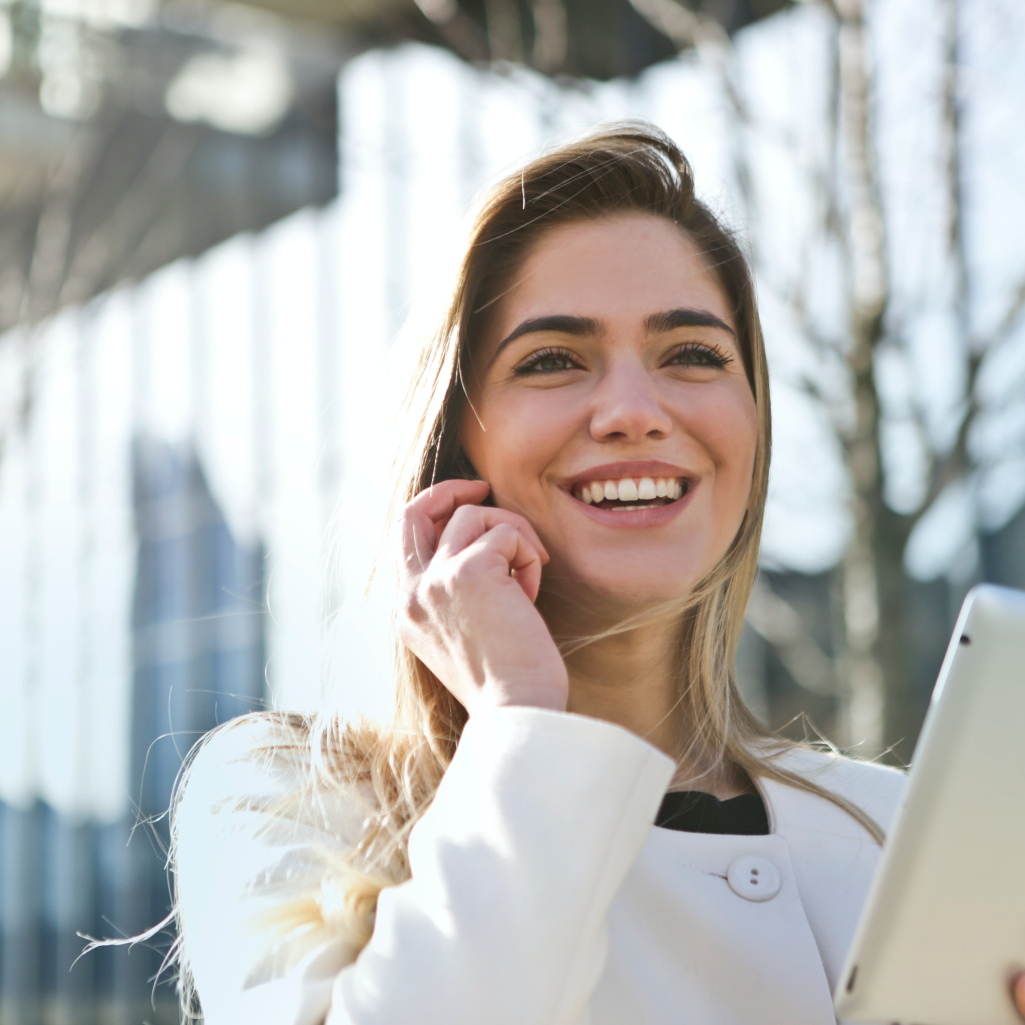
[399,481,569,714]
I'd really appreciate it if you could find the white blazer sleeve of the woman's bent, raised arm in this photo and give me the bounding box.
[172,708,674,1025]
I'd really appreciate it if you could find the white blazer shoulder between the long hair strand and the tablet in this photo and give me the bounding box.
[758,745,907,831]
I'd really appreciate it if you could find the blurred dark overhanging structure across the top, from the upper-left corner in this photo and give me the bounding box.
[0,0,788,330]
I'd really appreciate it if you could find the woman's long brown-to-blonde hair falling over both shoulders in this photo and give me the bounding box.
[168,122,882,1016]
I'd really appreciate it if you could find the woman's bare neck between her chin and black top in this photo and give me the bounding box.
[539,595,751,800]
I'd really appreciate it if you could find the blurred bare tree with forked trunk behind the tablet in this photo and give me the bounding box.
[631,0,1025,760]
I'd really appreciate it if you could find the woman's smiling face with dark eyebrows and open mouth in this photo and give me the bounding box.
[460,213,757,601]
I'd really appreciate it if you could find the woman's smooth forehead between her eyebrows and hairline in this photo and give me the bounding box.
[494,213,736,338]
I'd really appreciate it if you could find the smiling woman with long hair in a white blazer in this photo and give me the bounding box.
[175,125,1025,1025]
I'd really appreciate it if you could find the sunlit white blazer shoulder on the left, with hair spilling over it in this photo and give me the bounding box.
[172,713,375,1013]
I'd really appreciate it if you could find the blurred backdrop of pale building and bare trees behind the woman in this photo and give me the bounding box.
[0,0,1025,1025]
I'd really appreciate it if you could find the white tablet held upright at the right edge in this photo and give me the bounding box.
[834,584,1025,1025]
